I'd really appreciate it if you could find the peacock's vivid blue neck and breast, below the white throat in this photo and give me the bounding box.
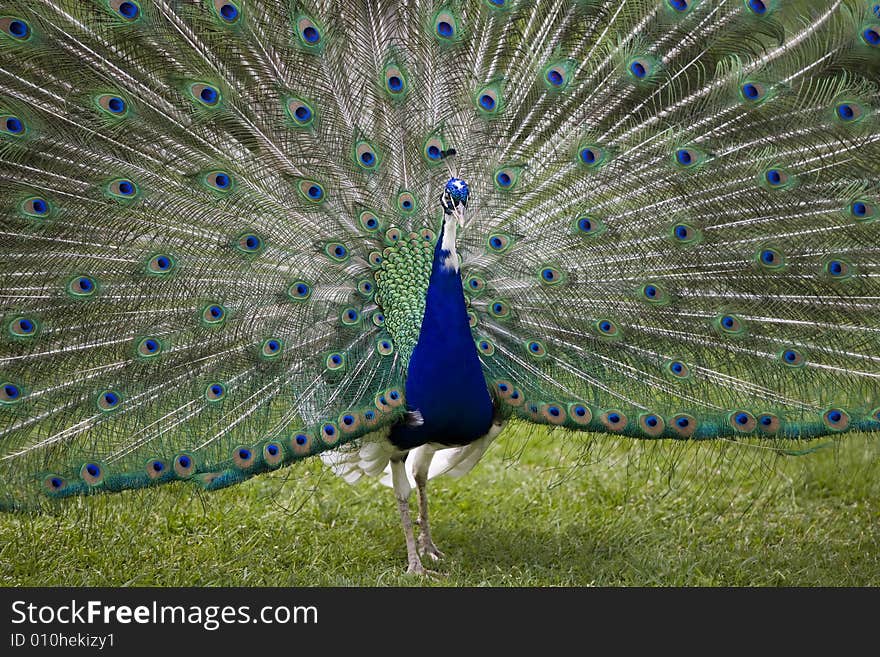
[391,218,493,448]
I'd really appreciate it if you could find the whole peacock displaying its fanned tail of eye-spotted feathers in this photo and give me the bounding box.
[0,0,880,574]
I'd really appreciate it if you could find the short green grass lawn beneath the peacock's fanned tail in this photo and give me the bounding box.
[0,428,880,586]
